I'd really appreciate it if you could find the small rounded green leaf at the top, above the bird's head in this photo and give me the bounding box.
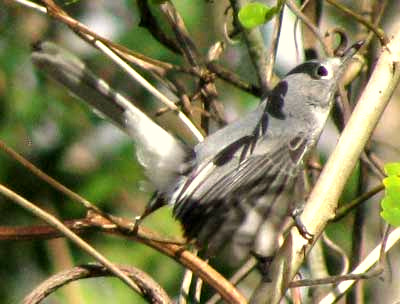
[238,2,279,29]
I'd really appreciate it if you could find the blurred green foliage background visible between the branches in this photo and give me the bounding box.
[0,0,400,303]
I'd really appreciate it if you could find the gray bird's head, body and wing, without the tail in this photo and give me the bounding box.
[171,58,356,258]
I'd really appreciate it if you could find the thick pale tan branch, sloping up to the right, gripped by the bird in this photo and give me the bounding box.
[252,32,400,303]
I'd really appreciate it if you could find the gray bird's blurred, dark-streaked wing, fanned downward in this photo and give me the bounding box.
[174,129,309,255]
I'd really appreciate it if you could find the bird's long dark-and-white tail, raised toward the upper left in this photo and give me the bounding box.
[31,42,190,192]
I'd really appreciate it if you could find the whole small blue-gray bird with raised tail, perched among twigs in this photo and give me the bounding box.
[32,42,361,258]
